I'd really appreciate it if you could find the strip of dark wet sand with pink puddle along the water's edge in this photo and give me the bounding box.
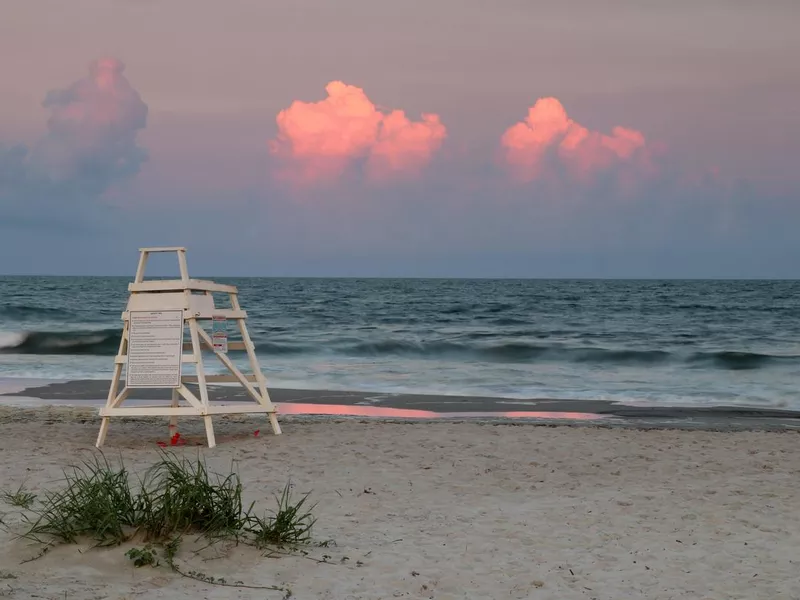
[0,380,800,431]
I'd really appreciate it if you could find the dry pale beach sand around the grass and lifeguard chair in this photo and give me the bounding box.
[0,408,800,600]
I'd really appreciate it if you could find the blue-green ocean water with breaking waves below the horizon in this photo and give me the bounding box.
[0,277,800,409]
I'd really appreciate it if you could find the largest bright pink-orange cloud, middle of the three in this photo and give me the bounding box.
[270,81,447,184]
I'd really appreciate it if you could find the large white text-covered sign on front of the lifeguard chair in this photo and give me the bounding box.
[125,310,183,388]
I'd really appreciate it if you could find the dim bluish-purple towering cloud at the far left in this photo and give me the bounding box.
[0,58,147,226]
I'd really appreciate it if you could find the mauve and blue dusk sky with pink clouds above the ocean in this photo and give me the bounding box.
[0,0,800,278]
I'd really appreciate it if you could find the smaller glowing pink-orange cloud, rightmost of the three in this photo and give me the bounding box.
[501,98,653,183]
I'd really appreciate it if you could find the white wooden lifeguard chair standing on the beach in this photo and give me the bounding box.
[97,247,281,448]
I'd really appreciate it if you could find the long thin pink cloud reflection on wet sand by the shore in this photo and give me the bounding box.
[276,402,603,421]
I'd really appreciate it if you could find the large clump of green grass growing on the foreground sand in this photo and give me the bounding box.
[14,453,315,552]
